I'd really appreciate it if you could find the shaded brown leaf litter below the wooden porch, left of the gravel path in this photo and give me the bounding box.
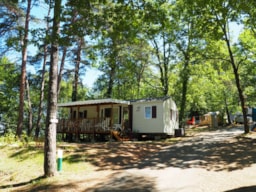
[62,142,167,170]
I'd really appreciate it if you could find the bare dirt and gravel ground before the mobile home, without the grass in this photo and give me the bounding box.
[4,128,256,192]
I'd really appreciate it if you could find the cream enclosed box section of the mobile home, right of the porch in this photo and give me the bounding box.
[131,97,179,135]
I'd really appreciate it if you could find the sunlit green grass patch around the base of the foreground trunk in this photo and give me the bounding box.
[0,141,93,191]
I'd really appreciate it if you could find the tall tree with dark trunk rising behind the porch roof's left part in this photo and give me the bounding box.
[63,0,97,101]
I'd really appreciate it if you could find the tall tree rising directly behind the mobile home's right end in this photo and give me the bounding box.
[173,0,200,125]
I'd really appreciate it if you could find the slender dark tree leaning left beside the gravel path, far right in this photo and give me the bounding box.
[187,0,249,133]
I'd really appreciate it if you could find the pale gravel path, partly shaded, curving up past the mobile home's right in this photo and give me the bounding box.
[86,128,256,192]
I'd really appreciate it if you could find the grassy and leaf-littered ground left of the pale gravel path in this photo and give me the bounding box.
[0,138,180,192]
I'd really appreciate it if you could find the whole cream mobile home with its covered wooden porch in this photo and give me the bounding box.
[57,97,179,139]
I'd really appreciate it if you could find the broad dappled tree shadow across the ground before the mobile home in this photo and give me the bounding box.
[64,134,256,171]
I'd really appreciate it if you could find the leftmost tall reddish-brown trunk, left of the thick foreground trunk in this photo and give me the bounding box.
[16,0,31,137]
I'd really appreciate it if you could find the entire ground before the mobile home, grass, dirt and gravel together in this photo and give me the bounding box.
[0,128,256,192]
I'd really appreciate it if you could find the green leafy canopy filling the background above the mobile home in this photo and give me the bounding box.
[0,0,256,136]
